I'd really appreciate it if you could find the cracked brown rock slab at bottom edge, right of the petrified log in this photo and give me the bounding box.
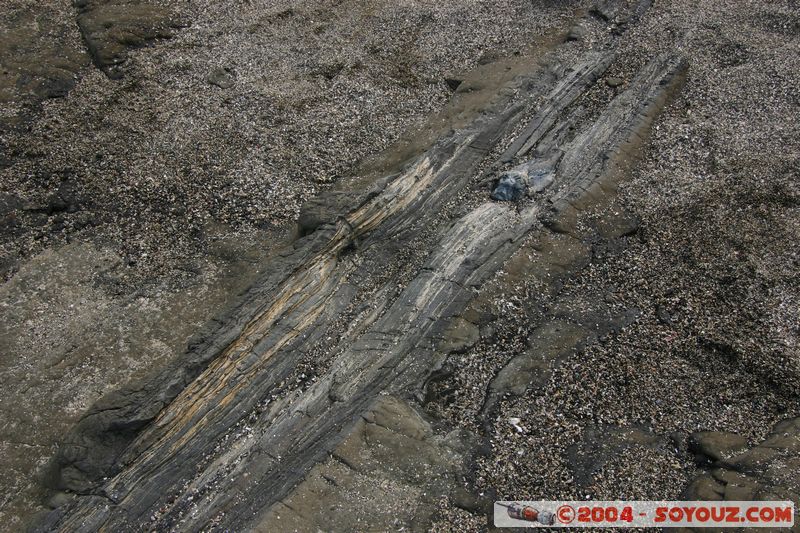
[253,396,477,533]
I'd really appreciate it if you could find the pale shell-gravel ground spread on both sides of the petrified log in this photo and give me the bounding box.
[0,0,800,530]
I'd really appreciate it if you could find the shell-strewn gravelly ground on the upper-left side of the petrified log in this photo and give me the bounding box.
[0,0,588,531]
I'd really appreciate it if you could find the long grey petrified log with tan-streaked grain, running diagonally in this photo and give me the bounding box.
[37,30,686,531]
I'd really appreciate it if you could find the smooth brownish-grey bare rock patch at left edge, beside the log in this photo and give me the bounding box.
[0,231,282,531]
